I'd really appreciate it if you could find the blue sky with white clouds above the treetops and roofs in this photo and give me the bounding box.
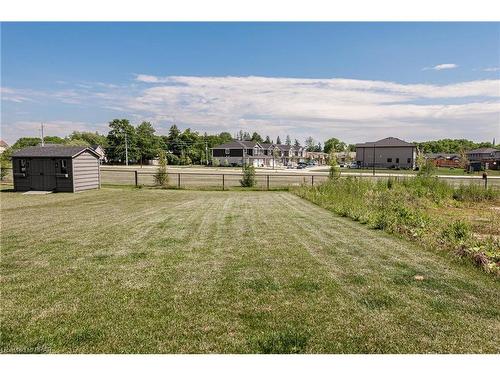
[0,22,500,143]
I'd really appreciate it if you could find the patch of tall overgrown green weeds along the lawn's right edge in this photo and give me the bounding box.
[294,175,500,274]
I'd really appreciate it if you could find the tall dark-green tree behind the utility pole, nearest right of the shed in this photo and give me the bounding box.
[106,119,139,162]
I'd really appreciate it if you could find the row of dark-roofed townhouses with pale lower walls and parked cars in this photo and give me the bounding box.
[212,139,328,168]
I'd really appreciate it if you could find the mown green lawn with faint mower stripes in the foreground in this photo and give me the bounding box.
[0,188,500,353]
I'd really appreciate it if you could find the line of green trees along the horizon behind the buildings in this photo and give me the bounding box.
[2,119,498,165]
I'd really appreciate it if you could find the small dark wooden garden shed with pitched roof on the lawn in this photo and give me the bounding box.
[12,146,101,192]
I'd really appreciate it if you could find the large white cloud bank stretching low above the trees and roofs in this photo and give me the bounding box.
[2,74,500,142]
